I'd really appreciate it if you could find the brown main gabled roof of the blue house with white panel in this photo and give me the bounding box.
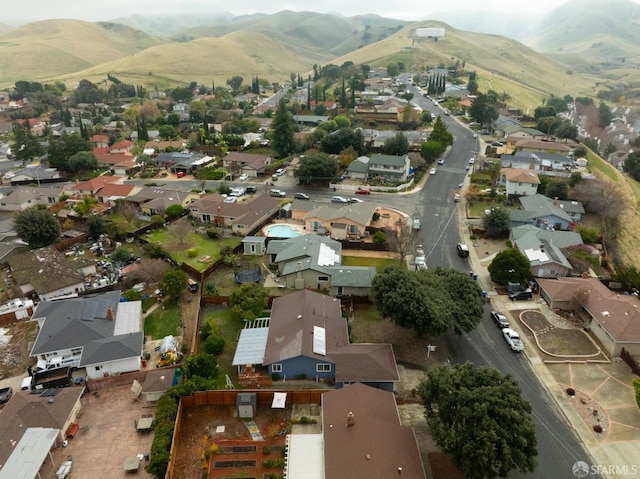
[264,290,349,365]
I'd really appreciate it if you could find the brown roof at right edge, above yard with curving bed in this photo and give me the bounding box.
[538,278,640,343]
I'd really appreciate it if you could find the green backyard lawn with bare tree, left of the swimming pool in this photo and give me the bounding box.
[145,227,241,271]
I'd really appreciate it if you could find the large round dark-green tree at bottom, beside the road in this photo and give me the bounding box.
[418,362,538,479]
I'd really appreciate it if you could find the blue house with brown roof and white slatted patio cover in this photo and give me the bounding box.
[233,290,400,391]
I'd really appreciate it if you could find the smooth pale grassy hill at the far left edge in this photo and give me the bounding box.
[0,20,168,85]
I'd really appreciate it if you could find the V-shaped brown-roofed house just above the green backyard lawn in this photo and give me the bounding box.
[189,193,280,236]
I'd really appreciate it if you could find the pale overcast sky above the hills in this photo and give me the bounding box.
[6,0,592,24]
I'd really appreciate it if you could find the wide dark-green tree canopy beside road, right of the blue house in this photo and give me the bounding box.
[369,266,483,336]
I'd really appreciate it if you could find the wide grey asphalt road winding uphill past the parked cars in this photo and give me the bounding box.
[400,91,592,479]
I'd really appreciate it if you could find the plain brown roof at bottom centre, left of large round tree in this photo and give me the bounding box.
[322,384,425,479]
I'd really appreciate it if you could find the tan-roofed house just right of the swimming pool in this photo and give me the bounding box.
[302,202,376,240]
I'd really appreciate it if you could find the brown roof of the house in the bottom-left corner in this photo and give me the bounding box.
[0,386,85,468]
